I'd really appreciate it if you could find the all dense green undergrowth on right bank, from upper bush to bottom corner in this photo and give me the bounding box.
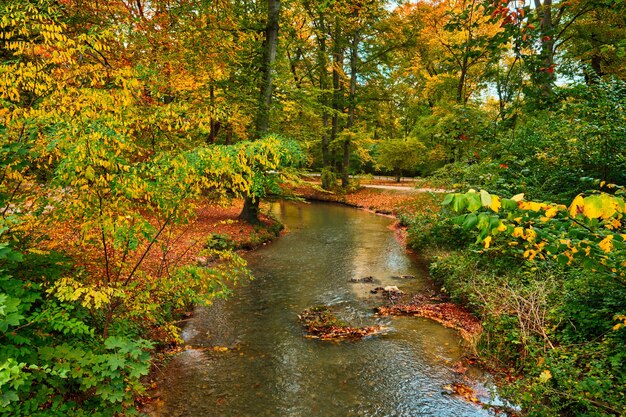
[403,82,626,416]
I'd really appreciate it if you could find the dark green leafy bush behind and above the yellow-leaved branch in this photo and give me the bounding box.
[483,80,626,202]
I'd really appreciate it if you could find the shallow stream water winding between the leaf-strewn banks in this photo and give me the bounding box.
[151,202,500,417]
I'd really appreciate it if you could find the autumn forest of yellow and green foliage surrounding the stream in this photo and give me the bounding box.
[0,0,626,416]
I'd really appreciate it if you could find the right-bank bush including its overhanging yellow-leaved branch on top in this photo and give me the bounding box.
[428,186,626,416]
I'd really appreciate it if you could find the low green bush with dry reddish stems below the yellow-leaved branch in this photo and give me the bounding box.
[431,245,626,417]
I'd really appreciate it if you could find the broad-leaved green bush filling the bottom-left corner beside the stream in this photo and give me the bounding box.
[0,243,152,417]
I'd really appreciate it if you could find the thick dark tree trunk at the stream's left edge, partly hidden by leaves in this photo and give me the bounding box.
[239,0,280,224]
